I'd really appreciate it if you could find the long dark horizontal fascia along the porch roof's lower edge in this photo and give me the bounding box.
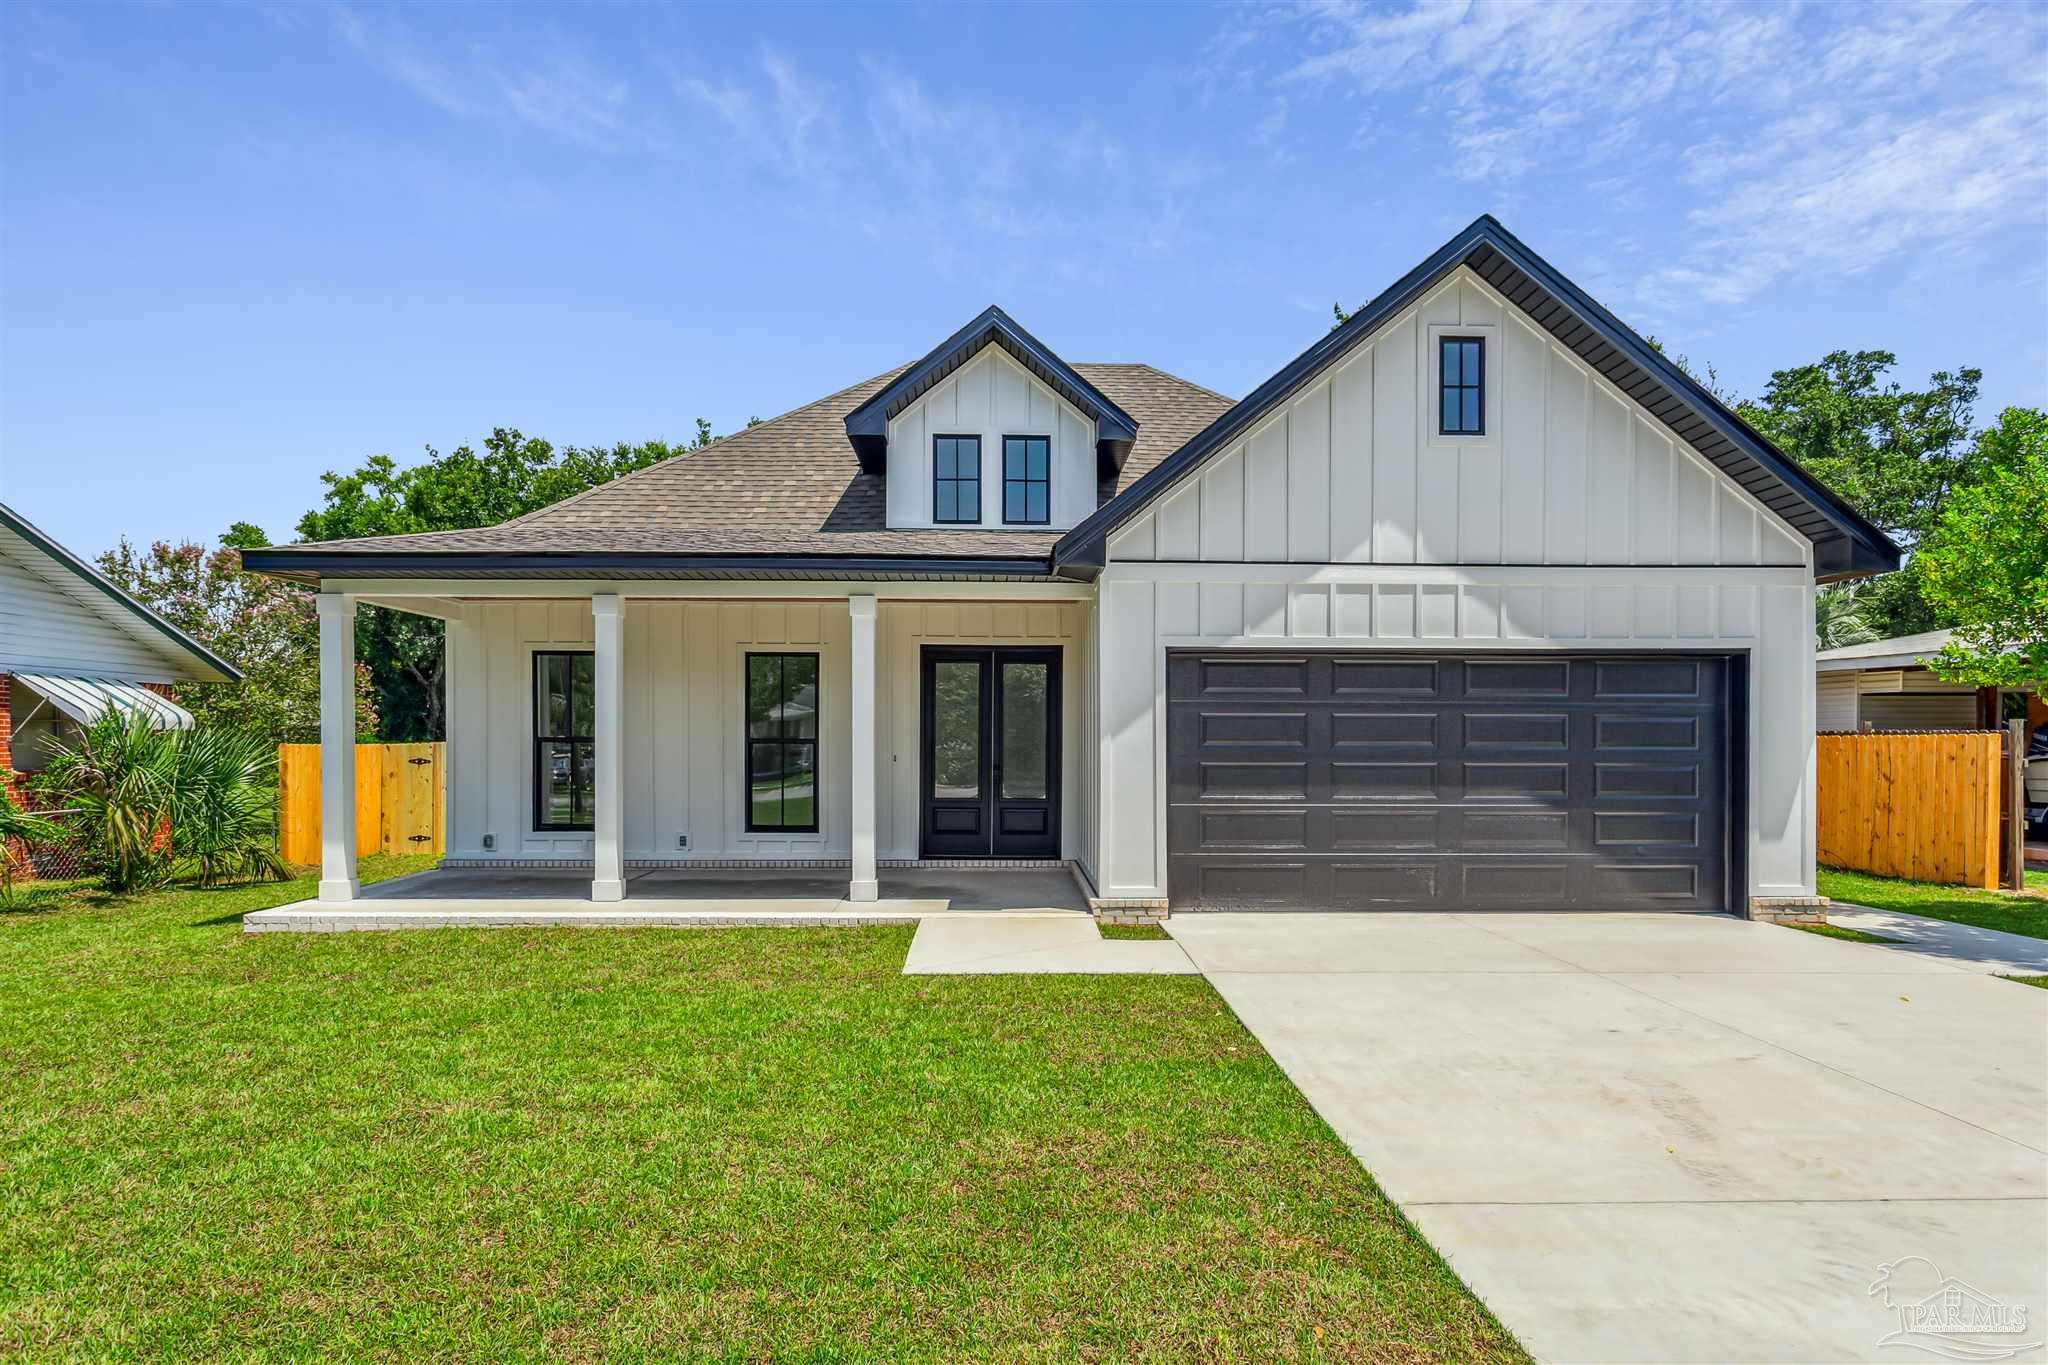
[242,542,1053,583]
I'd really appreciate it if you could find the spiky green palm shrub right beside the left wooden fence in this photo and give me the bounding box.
[170,729,291,886]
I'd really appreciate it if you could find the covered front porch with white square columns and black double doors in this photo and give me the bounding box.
[301,577,1096,923]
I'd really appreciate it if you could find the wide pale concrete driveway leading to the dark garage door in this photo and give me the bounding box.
[1169,915,2048,1361]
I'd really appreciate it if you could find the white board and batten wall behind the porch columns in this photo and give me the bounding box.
[446,598,1087,862]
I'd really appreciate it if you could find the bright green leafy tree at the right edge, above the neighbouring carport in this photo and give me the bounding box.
[1911,407,2048,688]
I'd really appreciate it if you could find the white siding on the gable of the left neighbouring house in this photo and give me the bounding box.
[0,526,199,681]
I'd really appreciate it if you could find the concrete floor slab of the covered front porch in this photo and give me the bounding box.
[242,868,1087,933]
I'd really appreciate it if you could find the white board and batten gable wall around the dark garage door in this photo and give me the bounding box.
[1098,270,1815,896]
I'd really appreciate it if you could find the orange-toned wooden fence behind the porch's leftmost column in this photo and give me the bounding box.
[276,743,449,866]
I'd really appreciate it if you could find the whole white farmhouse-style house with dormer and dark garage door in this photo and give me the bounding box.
[244,217,1898,913]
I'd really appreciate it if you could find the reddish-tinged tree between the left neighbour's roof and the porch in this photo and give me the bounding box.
[98,536,377,745]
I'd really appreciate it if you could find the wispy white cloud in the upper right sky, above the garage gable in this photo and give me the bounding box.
[1212,0,2048,309]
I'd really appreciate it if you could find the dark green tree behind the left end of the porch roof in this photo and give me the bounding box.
[299,431,696,741]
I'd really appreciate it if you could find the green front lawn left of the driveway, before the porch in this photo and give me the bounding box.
[0,860,1522,1361]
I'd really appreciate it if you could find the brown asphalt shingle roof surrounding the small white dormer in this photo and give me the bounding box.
[276,364,1231,559]
